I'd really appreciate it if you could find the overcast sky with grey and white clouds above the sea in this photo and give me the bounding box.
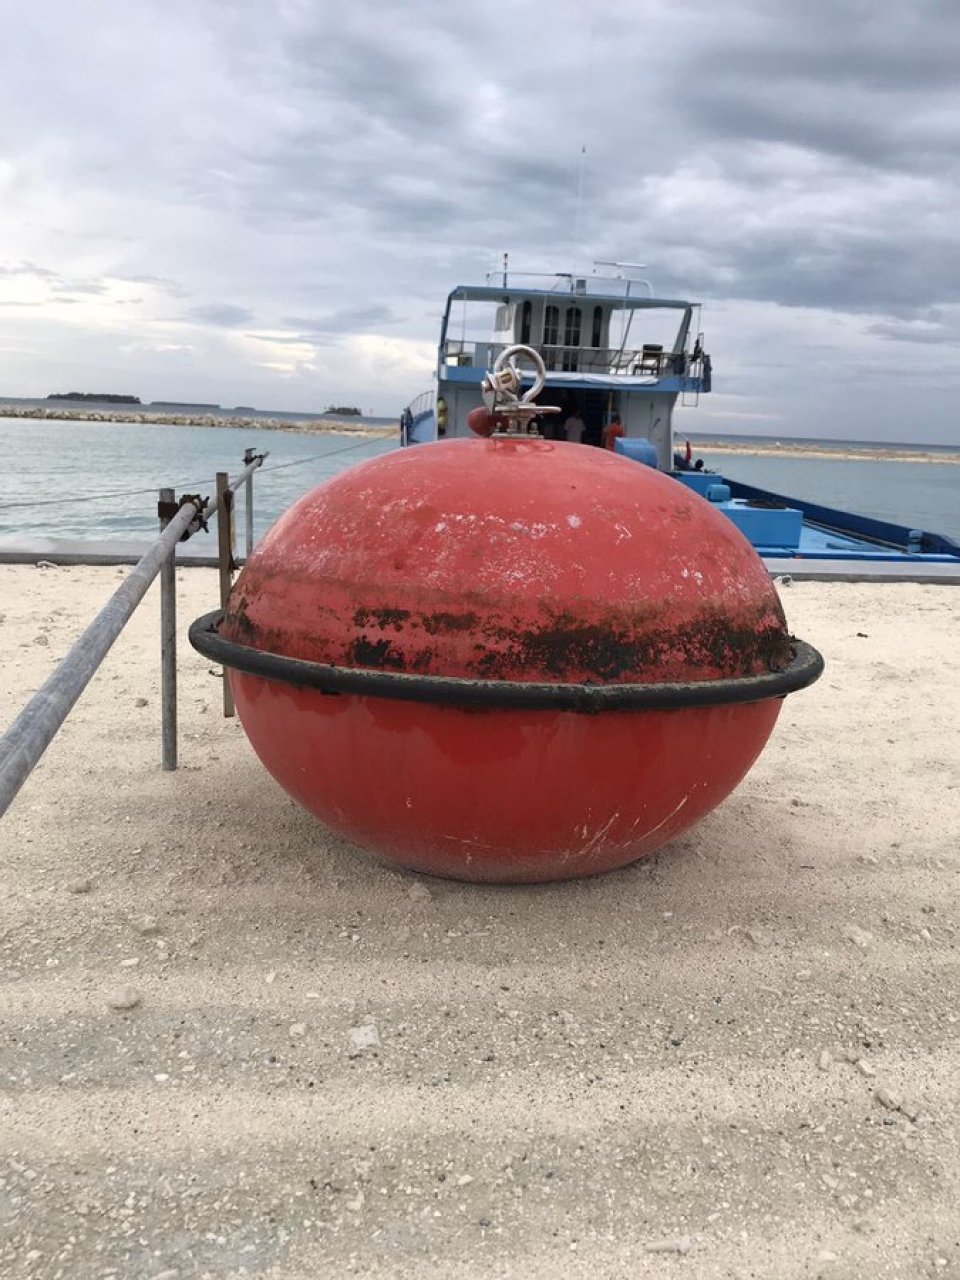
[0,0,960,444]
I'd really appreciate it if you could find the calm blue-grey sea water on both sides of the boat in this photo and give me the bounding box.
[0,419,960,549]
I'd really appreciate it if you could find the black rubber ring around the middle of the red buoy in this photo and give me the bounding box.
[189,609,823,714]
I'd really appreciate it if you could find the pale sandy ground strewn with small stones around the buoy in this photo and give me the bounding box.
[0,570,960,1280]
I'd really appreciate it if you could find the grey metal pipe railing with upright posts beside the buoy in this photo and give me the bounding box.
[0,449,268,817]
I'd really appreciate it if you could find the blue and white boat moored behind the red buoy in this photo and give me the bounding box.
[399,255,960,580]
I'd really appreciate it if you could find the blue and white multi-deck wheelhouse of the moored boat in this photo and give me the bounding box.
[401,264,712,460]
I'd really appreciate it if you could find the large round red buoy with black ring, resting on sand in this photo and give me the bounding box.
[191,435,820,881]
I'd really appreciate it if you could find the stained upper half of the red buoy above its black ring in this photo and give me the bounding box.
[220,436,794,685]
